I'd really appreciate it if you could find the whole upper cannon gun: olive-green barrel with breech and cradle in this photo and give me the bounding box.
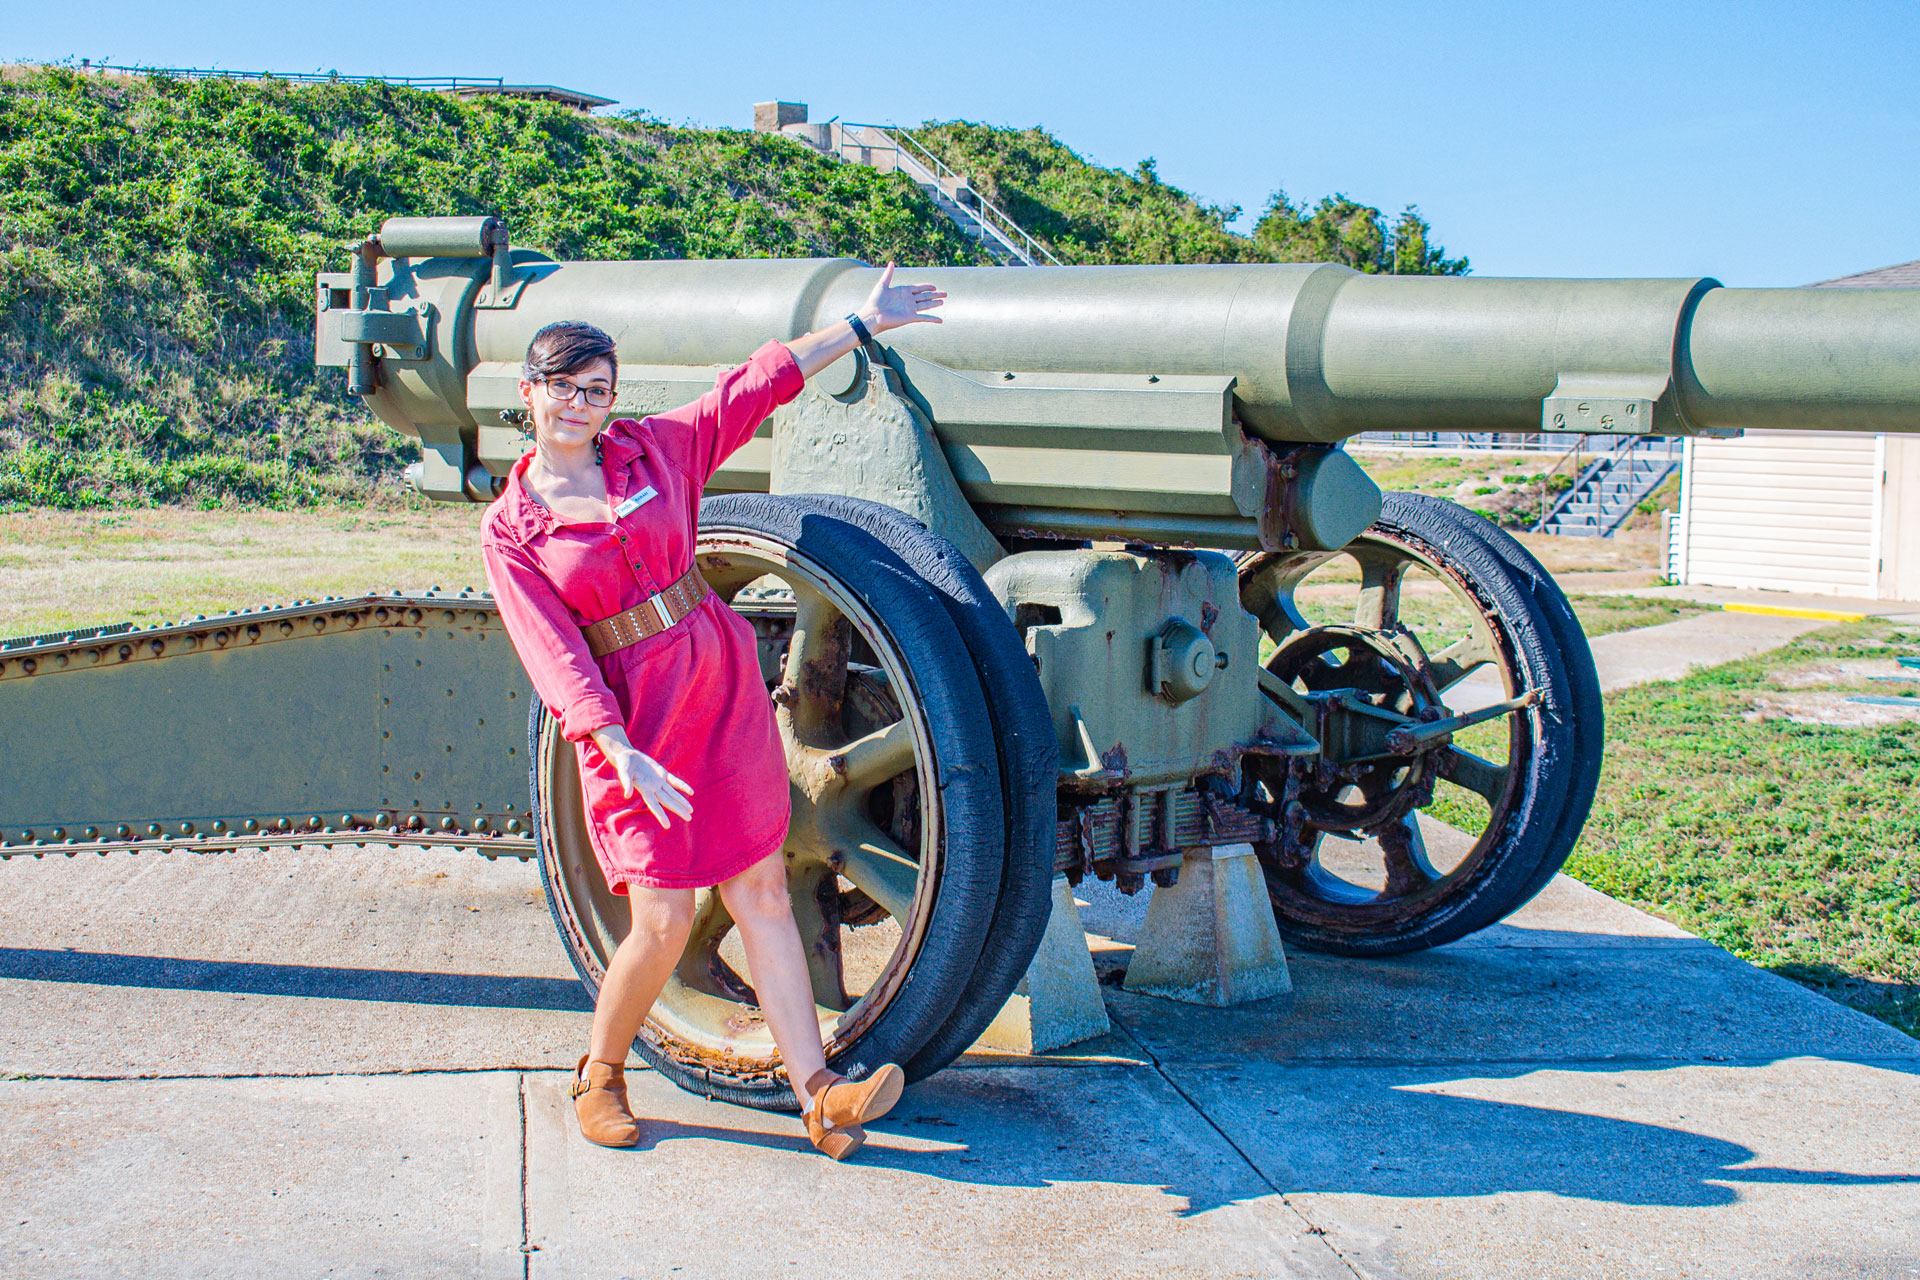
[317,219,1920,547]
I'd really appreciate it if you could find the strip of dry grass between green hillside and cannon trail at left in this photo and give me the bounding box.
[0,505,486,635]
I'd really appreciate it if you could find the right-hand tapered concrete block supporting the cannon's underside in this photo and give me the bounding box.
[1125,844,1294,1006]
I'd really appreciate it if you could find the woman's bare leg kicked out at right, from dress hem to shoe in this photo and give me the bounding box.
[720,850,828,1109]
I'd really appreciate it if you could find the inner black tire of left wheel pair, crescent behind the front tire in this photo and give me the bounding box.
[771,493,1060,1080]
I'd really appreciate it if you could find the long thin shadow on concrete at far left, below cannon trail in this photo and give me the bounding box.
[0,946,593,1011]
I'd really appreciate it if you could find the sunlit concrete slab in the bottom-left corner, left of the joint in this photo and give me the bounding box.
[0,1073,522,1280]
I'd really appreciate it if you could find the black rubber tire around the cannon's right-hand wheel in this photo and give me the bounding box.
[1275,493,1605,956]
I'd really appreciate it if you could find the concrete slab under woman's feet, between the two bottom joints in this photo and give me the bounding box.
[528,1067,1354,1280]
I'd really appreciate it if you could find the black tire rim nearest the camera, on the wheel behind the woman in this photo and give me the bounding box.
[530,493,1006,1111]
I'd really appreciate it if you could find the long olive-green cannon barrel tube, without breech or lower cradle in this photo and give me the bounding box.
[495,261,1920,443]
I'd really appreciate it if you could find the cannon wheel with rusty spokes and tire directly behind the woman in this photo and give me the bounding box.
[534,495,1006,1109]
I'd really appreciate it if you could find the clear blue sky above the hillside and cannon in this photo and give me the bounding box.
[0,0,1920,284]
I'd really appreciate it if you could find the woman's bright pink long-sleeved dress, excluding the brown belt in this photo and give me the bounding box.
[480,342,804,892]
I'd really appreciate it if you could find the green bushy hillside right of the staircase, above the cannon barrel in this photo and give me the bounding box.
[908,121,1467,274]
